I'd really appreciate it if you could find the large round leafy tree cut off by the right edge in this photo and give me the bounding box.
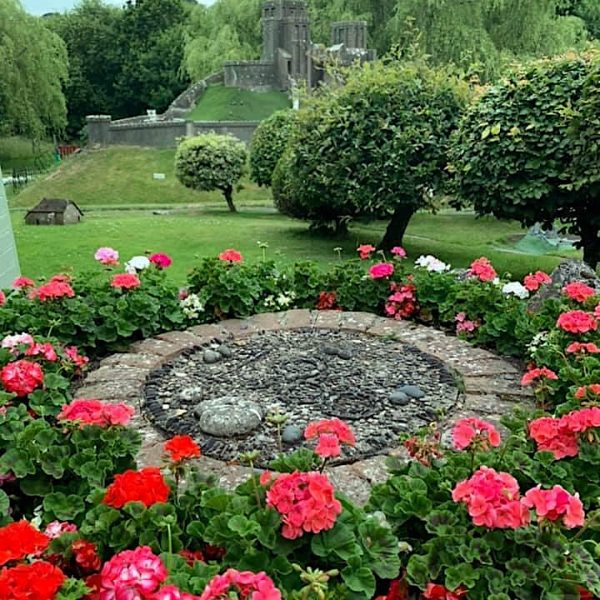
[449,54,600,268]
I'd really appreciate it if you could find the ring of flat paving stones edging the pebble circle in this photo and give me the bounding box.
[77,309,532,504]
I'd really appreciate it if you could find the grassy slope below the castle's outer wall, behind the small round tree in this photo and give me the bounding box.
[10,146,271,208]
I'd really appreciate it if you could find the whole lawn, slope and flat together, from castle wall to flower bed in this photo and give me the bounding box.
[10,147,578,282]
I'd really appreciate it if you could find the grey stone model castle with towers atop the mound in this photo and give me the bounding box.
[224,0,376,91]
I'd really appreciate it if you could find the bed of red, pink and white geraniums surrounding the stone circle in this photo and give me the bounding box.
[0,247,600,600]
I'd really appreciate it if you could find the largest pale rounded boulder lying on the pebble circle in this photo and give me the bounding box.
[194,396,263,438]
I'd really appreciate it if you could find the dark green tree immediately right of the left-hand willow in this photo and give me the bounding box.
[47,0,125,136]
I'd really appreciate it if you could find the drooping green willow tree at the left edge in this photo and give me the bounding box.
[0,0,67,139]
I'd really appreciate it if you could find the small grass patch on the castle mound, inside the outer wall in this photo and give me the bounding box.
[187,85,290,121]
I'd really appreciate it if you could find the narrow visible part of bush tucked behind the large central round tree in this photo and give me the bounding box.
[250,110,297,186]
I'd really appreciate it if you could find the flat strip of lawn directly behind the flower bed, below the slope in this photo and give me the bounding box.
[13,207,580,282]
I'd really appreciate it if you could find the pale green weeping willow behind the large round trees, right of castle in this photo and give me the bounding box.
[388,0,587,79]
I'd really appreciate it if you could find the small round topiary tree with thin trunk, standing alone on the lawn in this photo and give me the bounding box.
[175,133,248,212]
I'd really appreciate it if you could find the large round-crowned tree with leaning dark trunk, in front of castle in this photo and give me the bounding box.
[276,62,469,249]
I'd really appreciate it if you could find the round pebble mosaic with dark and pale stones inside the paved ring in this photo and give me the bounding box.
[143,329,462,467]
